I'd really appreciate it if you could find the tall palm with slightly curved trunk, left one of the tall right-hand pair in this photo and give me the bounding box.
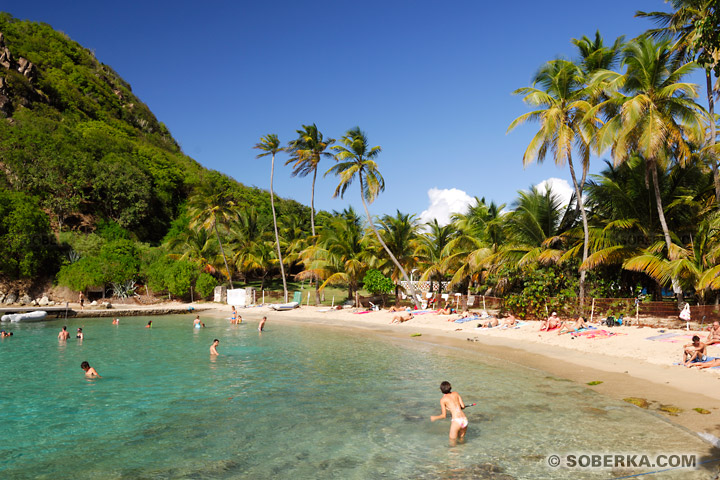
[508,60,592,300]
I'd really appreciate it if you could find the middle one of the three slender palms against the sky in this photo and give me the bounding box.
[285,123,335,237]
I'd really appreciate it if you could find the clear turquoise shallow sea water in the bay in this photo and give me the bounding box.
[0,315,708,480]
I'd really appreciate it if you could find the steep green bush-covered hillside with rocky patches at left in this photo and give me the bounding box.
[0,13,309,243]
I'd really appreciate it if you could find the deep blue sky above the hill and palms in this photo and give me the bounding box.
[0,0,704,223]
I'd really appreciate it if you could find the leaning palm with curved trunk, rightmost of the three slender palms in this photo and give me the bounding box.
[325,127,420,308]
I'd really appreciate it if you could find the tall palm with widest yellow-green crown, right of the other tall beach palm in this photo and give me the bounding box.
[588,37,704,303]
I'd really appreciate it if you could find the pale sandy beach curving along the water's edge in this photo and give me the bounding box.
[69,303,720,447]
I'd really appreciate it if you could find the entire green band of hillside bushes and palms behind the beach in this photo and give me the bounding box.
[0,4,720,315]
